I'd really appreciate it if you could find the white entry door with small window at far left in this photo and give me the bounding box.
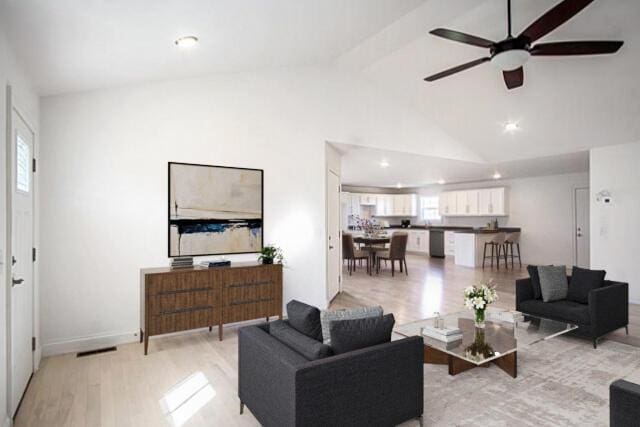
[10,108,34,415]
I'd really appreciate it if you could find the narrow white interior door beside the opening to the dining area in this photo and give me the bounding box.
[327,171,341,301]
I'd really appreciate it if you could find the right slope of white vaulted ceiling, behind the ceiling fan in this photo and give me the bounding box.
[348,0,640,162]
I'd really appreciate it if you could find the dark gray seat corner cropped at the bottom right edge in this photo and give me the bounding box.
[609,380,640,427]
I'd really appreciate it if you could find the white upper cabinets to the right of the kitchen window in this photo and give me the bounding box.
[440,187,507,216]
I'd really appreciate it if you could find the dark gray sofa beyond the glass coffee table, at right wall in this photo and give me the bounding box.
[516,276,629,348]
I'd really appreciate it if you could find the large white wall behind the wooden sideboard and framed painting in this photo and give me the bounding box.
[41,68,475,354]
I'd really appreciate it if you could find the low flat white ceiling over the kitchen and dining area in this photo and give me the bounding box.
[332,144,589,187]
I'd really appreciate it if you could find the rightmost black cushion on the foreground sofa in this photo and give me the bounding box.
[329,314,396,354]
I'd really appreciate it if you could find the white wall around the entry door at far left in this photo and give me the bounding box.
[0,30,39,425]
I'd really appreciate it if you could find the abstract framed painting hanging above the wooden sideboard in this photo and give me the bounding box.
[169,162,264,257]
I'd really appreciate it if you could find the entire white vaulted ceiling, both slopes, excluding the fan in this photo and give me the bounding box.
[0,0,640,171]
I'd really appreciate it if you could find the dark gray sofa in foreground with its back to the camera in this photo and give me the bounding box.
[238,323,423,427]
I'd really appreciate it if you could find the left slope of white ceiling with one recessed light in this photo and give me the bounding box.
[0,0,423,95]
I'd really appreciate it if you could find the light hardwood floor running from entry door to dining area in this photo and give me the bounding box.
[15,255,640,427]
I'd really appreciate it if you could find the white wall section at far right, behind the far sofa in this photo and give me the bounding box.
[590,143,640,304]
